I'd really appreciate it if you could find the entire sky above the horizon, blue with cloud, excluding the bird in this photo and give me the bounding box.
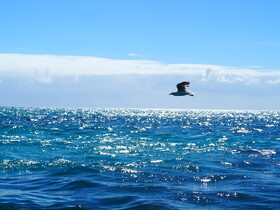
[0,0,280,110]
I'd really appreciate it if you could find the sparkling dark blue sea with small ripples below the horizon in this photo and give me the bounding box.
[0,107,280,209]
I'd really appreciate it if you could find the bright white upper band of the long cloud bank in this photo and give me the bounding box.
[0,54,280,85]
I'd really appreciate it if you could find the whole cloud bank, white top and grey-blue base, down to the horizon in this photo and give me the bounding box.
[0,54,280,110]
